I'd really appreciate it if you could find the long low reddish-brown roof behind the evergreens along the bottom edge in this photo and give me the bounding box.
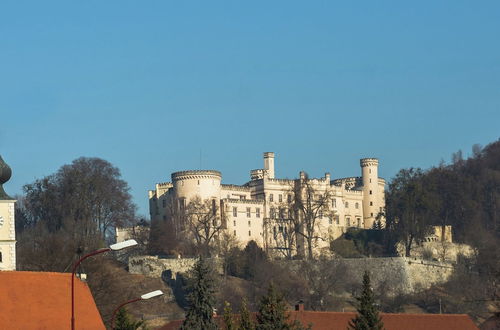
[160,311,478,330]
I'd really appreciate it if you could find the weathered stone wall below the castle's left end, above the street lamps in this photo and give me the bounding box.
[128,256,223,280]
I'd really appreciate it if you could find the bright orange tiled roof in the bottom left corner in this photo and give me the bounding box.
[0,271,105,330]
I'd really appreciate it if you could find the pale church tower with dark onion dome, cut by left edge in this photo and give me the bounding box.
[0,156,16,271]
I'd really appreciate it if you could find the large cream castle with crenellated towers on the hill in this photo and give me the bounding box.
[149,152,385,253]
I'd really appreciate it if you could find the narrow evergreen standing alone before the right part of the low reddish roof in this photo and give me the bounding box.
[349,271,384,330]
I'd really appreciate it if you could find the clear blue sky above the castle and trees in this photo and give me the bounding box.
[0,0,500,215]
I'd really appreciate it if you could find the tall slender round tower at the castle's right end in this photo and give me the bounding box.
[360,158,379,228]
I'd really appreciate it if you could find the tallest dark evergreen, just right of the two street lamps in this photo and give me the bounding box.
[181,257,217,330]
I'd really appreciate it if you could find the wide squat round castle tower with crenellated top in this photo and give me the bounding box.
[172,170,222,203]
